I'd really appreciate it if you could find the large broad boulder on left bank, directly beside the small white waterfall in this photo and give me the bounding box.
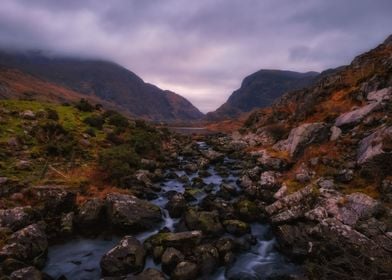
[106,193,162,231]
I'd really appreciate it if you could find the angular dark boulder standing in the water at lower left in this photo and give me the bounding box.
[100,236,146,276]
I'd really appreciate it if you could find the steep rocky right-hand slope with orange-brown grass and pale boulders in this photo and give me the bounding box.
[220,33,392,279]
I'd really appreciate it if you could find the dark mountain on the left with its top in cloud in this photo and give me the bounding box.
[0,52,203,121]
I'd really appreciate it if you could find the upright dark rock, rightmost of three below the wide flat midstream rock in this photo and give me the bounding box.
[194,244,219,275]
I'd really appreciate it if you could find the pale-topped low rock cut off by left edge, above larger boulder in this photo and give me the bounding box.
[0,206,37,231]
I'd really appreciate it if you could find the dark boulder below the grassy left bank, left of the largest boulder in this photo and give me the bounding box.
[32,185,76,215]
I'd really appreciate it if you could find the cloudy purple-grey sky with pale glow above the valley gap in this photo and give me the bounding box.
[0,0,392,112]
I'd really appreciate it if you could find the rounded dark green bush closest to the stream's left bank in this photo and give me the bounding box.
[98,145,140,184]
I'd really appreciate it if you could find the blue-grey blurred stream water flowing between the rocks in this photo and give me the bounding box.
[44,142,300,280]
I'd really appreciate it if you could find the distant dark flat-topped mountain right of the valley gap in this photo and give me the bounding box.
[206,69,318,120]
